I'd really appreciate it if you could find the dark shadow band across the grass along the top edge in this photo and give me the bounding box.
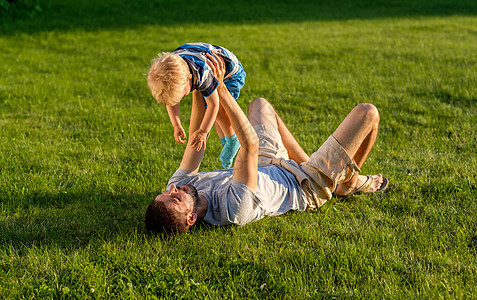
[1,0,477,35]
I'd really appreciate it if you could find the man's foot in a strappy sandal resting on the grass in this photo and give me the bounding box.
[335,174,389,197]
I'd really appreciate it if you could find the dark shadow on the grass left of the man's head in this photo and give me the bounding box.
[0,193,152,249]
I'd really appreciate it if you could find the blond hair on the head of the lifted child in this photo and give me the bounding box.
[147,52,189,106]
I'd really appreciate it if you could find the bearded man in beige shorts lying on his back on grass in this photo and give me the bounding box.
[145,55,388,233]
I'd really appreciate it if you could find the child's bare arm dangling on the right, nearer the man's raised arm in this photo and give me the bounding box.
[190,90,220,151]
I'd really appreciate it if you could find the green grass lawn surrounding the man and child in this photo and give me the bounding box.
[0,0,477,299]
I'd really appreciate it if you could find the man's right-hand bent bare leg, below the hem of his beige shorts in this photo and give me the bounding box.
[333,104,383,196]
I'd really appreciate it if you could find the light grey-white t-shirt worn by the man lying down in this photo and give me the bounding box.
[167,165,307,225]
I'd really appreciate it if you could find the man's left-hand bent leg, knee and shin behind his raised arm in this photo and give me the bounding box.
[248,98,310,164]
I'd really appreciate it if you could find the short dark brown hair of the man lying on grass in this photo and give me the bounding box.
[145,200,189,234]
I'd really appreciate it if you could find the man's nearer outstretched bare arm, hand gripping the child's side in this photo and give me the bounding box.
[207,54,258,192]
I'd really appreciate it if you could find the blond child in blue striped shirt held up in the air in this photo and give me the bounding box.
[147,43,246,168]
